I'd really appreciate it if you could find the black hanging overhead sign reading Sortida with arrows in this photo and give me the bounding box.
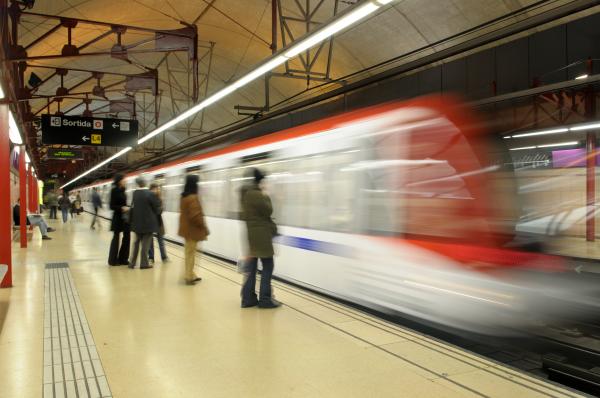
[42,115,138,147]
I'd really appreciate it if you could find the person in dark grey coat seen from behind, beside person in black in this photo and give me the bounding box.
[129,176,160,269]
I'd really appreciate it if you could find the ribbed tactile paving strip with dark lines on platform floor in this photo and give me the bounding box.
[43,263,112,398]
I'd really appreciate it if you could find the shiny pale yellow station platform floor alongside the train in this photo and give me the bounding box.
[0,214,579,398]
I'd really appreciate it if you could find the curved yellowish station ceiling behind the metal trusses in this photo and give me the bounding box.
[12,0,568,177]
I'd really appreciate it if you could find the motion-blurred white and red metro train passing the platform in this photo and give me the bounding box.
[81,97,599,334]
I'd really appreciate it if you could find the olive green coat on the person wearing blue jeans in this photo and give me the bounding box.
[240,184,277,258]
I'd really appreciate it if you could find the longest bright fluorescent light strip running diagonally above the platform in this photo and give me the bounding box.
[61,0,394,188]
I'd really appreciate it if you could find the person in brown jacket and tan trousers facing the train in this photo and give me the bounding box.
[178,174,210,285]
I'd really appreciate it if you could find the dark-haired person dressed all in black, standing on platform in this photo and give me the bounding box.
[108,173,130,265]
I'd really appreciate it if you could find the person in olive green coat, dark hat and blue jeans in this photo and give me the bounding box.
[240,169,281,308]
